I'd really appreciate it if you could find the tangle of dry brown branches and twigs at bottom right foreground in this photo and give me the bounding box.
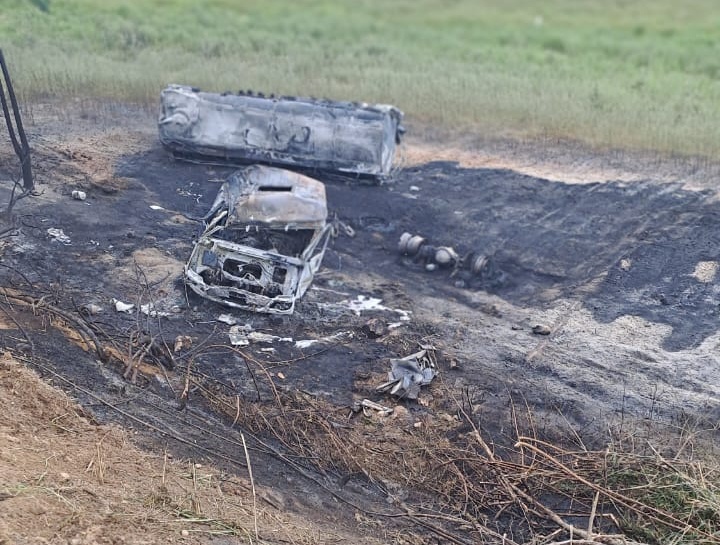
[194,357,720,545]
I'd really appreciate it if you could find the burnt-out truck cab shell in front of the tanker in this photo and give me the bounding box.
[185,165,331,314]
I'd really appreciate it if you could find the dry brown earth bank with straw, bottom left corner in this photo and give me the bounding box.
[0,353,376,544]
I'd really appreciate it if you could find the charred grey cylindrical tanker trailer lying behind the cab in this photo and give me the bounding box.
[159,85,404,180]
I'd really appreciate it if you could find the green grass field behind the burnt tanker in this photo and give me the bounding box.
[0,0,720,158]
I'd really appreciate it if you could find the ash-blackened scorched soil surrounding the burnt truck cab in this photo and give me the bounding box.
[0,102,720,540]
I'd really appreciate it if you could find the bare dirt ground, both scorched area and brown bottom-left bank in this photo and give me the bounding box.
[0,103,720,543]
